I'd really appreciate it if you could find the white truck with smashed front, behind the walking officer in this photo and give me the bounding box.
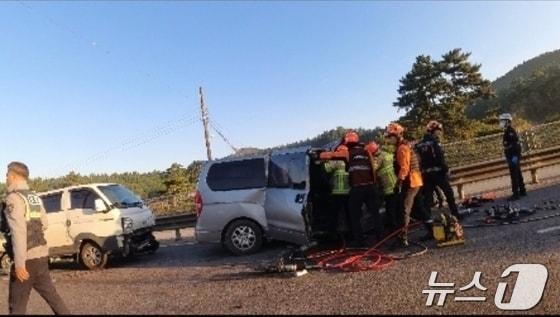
[0,184,159,270]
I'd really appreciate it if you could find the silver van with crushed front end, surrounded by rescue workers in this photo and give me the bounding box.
[195,148,376,255]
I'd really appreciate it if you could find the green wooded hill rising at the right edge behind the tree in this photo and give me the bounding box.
[467,50,560,123]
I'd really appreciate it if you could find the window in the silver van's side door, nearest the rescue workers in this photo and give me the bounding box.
[268,153,308,189]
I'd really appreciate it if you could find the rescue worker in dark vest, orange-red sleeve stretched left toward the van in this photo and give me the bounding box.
[319,132,383,246]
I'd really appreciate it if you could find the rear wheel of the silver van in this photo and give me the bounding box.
[224,219,263,255]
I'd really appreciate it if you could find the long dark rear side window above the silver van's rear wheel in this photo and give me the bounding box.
[206,158,266,191]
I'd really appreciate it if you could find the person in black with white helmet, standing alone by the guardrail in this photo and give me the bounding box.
[499,113,527,201]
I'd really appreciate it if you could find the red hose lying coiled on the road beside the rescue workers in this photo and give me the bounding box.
[307,222,421,272]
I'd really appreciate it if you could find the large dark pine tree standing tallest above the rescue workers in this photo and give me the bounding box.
[393,49,493,139]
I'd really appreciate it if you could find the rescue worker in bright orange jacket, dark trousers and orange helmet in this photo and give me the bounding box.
[385,123,433,246]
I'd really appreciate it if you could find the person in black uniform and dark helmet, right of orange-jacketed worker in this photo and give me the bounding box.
[416,121,461,219]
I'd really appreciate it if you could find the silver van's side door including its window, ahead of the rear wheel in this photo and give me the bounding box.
[265,152,309,244]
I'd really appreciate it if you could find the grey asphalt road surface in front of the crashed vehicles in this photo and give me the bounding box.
[0,185,560,315]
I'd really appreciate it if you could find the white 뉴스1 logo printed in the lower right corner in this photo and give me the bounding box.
[422,264,548,311]
